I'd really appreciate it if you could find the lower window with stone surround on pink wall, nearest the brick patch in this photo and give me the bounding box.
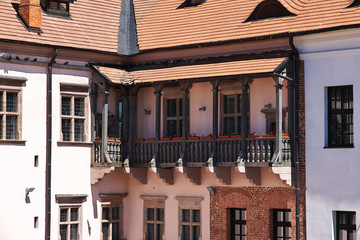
[176,197,203,240]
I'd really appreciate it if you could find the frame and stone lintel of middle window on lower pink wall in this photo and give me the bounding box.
[140,195,167,240]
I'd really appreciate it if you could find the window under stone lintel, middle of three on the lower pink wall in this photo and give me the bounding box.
[145,207,164,240]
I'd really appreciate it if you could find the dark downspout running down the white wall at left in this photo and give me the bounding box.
[45,48,58,240]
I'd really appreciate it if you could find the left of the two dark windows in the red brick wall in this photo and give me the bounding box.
[230,208,246,240]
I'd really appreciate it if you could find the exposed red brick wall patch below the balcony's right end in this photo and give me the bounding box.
[210,187,295,240]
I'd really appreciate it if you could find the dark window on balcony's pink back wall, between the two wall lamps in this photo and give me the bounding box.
[164,98,183,137]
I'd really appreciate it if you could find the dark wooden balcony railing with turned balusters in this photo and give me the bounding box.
[93,137,291,167]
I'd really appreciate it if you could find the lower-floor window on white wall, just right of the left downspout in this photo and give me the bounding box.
[59,206,80,240]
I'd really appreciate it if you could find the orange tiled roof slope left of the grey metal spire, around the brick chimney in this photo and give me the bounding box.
[0,0,121,53]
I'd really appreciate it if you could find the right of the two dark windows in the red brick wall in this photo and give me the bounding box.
[273,209,291,240]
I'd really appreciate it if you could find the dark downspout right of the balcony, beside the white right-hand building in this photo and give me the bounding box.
[289,36,300,240]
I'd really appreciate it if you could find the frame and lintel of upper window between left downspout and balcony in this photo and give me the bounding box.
[60,84,89,143]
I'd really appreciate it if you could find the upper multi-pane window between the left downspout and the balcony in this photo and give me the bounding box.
[61,95,86,142]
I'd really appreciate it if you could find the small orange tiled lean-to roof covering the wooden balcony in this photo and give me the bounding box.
[97,58,285,84]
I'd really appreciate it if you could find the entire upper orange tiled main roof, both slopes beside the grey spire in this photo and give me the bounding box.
[0,0,360,53]
